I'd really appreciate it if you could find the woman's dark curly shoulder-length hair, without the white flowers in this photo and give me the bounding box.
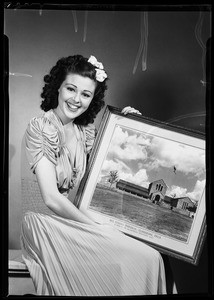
[40,55,107,125]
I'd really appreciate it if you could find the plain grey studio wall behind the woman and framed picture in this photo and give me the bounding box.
[4,5,211,293]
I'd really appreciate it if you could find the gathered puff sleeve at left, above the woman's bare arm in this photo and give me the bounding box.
[24,117,59,173]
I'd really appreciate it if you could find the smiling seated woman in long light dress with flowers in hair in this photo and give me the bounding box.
[21,55,166,296]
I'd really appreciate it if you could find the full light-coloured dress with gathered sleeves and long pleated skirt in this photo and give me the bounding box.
[21,110,166,296]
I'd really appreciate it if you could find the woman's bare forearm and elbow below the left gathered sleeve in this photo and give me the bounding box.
[35,156,97,225]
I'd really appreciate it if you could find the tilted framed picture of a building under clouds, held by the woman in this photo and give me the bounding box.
[75,106,206,264]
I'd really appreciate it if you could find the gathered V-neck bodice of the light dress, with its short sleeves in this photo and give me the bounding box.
[21,110,95,213]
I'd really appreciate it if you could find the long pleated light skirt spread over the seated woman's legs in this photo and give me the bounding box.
[21,212,166,296]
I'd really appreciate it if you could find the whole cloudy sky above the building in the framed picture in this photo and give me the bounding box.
[99,126,205,201]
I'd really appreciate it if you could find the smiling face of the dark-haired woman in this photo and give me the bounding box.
[55,73,96,124]
